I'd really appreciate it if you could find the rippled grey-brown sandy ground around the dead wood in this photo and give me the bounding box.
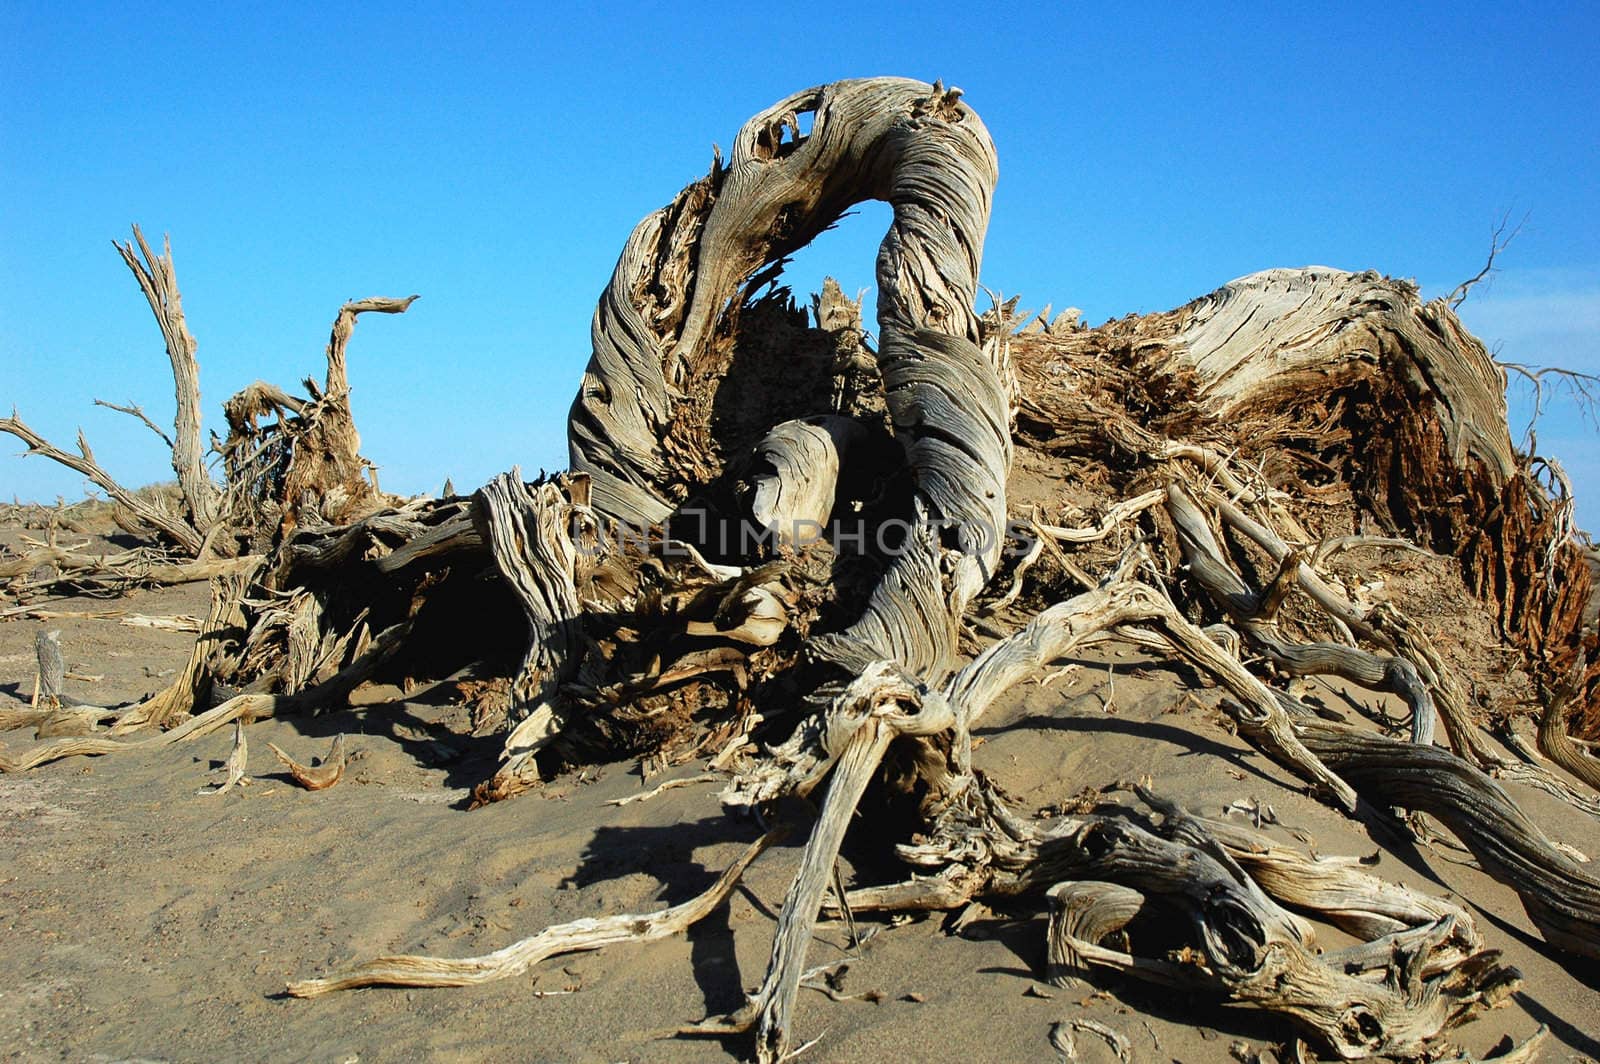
[0,524,1600,1064]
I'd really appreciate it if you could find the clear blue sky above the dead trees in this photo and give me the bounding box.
[0,0,1600,528]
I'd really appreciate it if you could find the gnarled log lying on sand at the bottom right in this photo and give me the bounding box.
[896,779,1520,1059]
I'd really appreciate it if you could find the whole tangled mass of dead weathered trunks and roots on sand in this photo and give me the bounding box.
[0,78,1600,1061]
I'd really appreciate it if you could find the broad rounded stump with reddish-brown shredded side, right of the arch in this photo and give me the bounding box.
[1013,267,1600,729]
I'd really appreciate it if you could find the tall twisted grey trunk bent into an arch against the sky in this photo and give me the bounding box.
[568,78,1011,681]
